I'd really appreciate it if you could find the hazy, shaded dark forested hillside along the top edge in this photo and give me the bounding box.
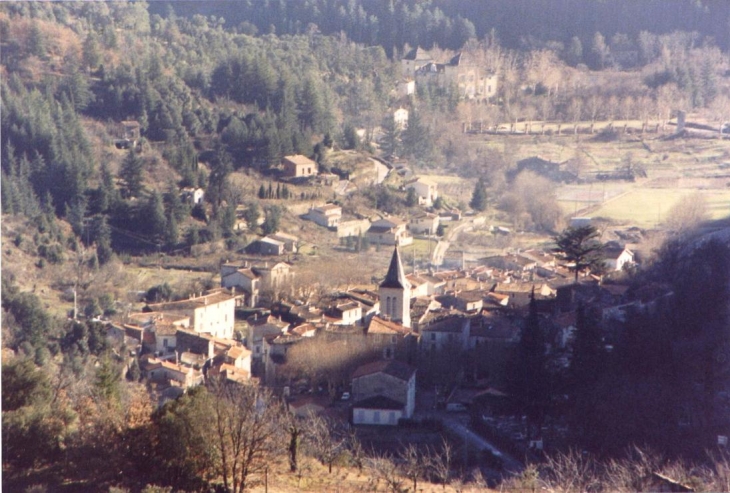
[152,0,730,55]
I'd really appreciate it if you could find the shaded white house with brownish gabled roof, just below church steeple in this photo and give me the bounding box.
[352,360,416,426]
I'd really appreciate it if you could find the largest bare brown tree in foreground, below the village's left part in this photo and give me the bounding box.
[212,381,285,493]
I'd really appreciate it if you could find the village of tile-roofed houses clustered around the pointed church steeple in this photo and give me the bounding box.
[108,131,644,477]
